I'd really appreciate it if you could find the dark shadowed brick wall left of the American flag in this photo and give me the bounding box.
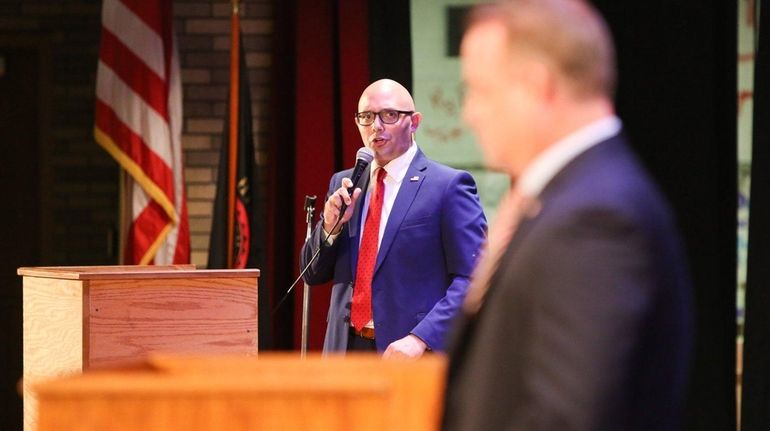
[0,0,109,264]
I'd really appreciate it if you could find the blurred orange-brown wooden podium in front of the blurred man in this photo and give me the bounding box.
[35,354,445,431]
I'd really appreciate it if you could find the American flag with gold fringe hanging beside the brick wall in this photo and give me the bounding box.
[94,0,190,265]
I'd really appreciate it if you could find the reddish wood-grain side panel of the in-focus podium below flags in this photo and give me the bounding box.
[87,271,257,368]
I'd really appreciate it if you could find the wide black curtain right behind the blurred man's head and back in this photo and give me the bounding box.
[594,0,736,431]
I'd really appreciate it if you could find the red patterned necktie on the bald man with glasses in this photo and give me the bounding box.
[350,168,388,331]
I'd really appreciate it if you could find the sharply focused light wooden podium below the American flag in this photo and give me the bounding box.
[18,265,259,431]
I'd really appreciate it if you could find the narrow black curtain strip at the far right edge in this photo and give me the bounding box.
[741,1,770,431]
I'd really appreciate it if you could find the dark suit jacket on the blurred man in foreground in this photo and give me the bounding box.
[443,137,691,431]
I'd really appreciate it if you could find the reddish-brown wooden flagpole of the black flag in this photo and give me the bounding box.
[227,0,240,268]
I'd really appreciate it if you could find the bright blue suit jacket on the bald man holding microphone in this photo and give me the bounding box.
[301,149,486,352]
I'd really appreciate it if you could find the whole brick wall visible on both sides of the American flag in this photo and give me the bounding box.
[0,0,273,266]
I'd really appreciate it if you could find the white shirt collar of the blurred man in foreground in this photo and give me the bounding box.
[517,115,622,196]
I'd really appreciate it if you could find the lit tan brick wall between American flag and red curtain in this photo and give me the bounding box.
[174,0,273,266]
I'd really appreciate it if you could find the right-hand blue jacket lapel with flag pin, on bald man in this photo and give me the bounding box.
[374,149,428,274]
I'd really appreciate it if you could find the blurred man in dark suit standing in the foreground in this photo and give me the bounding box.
[443,0,691,431]
